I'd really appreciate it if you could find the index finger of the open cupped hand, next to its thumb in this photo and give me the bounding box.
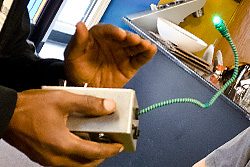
[90,23,127,41]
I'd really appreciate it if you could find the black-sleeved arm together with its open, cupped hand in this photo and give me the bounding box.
[0,3,156,91]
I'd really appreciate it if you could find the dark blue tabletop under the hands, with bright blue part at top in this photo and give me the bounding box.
[100,0,250,167]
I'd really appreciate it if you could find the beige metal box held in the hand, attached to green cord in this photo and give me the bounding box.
[42,86,140,152]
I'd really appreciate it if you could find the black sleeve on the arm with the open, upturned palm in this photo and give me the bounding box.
[0,7,65,91]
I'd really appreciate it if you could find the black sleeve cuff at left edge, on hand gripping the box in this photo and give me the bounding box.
[0,86,17,138]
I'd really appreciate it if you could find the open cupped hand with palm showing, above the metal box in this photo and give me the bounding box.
[64,22,157,88]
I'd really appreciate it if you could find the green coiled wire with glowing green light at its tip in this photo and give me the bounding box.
[139,16,239,115]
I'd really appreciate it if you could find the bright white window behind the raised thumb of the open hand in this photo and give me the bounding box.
[49,0,110,43]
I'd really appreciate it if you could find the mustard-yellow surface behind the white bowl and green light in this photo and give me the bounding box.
[159,0,239,57]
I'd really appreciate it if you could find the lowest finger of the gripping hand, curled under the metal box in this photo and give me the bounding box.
[71,134,124,160]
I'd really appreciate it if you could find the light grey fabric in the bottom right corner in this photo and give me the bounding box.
[205,127,250,167]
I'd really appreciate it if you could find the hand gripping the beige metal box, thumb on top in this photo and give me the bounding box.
[3,90,123,167]
